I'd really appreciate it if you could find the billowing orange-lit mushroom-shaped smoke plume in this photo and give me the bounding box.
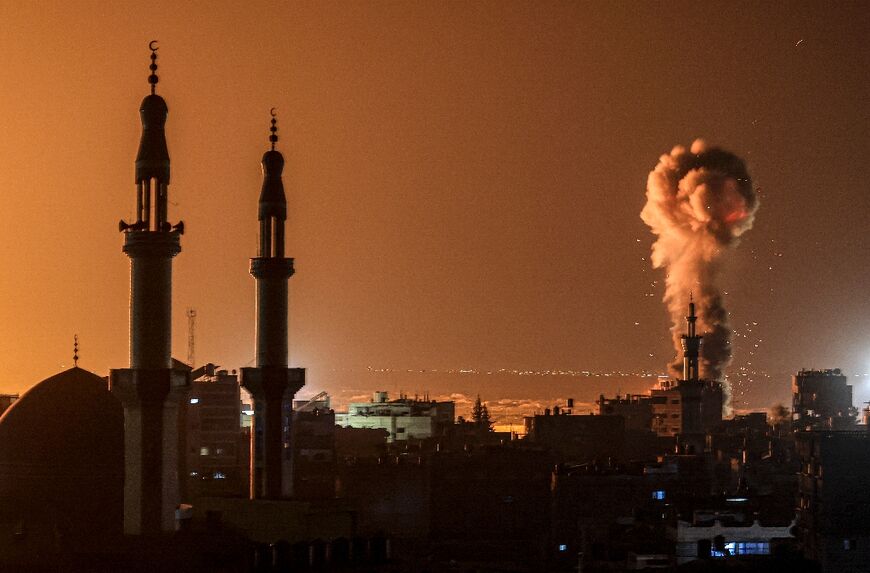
[640,139,758,380]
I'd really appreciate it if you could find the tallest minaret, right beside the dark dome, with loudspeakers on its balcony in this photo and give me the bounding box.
[111,42,189,535]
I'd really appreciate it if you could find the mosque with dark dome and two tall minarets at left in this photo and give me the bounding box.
[0,42,305,557]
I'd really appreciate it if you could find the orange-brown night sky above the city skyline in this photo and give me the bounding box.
[0,1,870,416]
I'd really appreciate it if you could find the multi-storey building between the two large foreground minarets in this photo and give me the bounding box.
[187,364,248,499]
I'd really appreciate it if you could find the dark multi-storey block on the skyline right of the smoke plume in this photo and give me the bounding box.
[792,368,857,430]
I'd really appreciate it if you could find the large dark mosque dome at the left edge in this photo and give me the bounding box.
[0,367,124,556]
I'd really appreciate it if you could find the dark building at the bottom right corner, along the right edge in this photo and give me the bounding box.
[795,431,870,573]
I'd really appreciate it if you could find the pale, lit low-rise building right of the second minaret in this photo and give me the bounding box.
[335,391,456,443]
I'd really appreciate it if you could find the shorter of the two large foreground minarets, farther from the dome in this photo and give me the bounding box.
[241,108,305,499]
